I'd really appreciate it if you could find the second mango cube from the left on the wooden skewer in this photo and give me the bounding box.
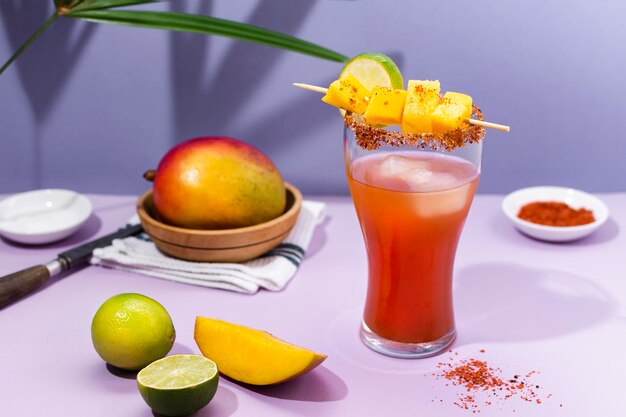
[363,87,406,126]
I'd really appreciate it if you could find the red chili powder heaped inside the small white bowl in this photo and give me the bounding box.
[517,201,596,226]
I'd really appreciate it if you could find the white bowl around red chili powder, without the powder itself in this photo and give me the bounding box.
[502,187,609,242]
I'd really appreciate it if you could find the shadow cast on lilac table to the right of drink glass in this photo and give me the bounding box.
[454,263,617,344]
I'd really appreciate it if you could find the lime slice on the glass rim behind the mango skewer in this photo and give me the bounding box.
[339,52,404,90]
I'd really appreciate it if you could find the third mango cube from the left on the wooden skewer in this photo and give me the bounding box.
[402,80,441,133]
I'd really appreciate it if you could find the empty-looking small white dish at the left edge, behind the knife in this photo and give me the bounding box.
[0,189,93,245]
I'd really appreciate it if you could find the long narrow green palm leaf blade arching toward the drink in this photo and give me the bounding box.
[65,9,348,62]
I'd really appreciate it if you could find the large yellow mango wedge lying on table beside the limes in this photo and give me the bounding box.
[194,317,326,385]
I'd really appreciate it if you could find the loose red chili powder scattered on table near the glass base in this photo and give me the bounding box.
[433,349,562,413]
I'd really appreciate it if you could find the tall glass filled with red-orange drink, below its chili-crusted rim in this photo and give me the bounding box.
[344,118,482,358]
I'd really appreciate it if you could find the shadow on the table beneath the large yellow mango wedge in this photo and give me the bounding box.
[224,365,348,402]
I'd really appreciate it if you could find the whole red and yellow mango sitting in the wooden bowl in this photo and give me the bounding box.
[153,137,286,229]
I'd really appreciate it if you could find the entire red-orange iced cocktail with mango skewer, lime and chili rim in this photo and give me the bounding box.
[295,52,509,358]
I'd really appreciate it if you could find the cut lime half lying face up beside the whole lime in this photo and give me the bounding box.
[137,355,219,416]
